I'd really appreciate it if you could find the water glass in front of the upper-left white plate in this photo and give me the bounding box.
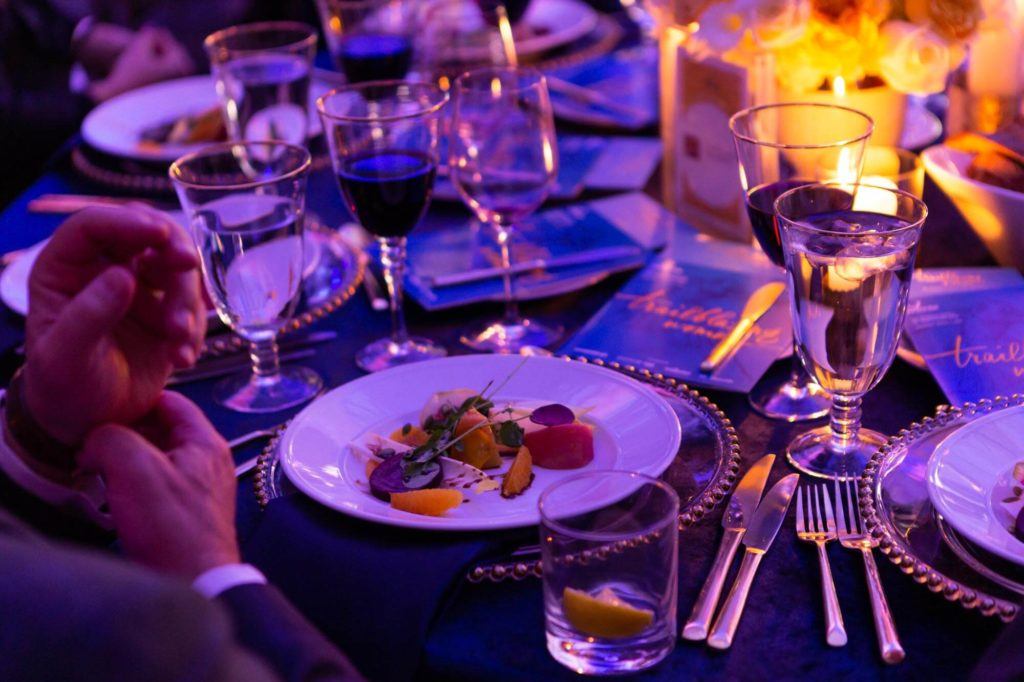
[204,22,316,144]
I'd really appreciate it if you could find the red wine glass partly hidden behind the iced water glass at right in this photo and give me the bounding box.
[729,102,874,422]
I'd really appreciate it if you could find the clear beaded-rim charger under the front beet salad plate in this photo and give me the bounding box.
[254,357,740,583]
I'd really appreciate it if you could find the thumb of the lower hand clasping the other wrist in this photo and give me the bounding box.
[77,424,170,497]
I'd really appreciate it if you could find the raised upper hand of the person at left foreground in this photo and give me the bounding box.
[24,208,206,445]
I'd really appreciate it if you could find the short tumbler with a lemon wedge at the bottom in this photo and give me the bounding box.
[539,471,679,675]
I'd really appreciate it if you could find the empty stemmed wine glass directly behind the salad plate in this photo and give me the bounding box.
[449,68,562,353]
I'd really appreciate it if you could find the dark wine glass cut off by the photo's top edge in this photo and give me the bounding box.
[316,0,415,83]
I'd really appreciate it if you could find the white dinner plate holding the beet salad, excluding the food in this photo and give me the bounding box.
[279,355,682,530]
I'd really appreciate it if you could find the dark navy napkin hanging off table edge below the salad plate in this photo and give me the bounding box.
[243,494,536,680]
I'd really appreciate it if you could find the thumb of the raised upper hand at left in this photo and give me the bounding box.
[42,265,135,353]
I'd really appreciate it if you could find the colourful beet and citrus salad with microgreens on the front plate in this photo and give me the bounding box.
[349,372,594,516]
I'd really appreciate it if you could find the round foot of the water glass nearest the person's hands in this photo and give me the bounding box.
[213,367,324,413]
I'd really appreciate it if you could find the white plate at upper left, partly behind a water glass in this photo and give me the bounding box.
[82,76,331,163]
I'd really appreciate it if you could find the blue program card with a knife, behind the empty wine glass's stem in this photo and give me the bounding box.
[407,204,648,310]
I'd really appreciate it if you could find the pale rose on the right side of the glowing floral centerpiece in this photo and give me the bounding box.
[879,22,951,94]
